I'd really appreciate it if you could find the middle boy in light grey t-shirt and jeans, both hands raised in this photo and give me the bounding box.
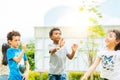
[49,28,78,80]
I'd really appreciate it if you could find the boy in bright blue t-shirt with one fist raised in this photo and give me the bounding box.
[6,31,29,80]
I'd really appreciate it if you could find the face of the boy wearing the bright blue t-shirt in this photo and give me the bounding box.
[9,36,20,48]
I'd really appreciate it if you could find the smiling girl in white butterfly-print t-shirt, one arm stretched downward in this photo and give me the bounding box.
[81,30,120,80]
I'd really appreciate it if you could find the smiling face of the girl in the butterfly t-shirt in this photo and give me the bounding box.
[105,32,117,46]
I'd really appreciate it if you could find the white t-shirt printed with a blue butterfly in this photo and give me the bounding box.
[98,50,120,80]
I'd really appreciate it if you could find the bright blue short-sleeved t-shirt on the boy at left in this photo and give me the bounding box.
[7,48,27,80]
